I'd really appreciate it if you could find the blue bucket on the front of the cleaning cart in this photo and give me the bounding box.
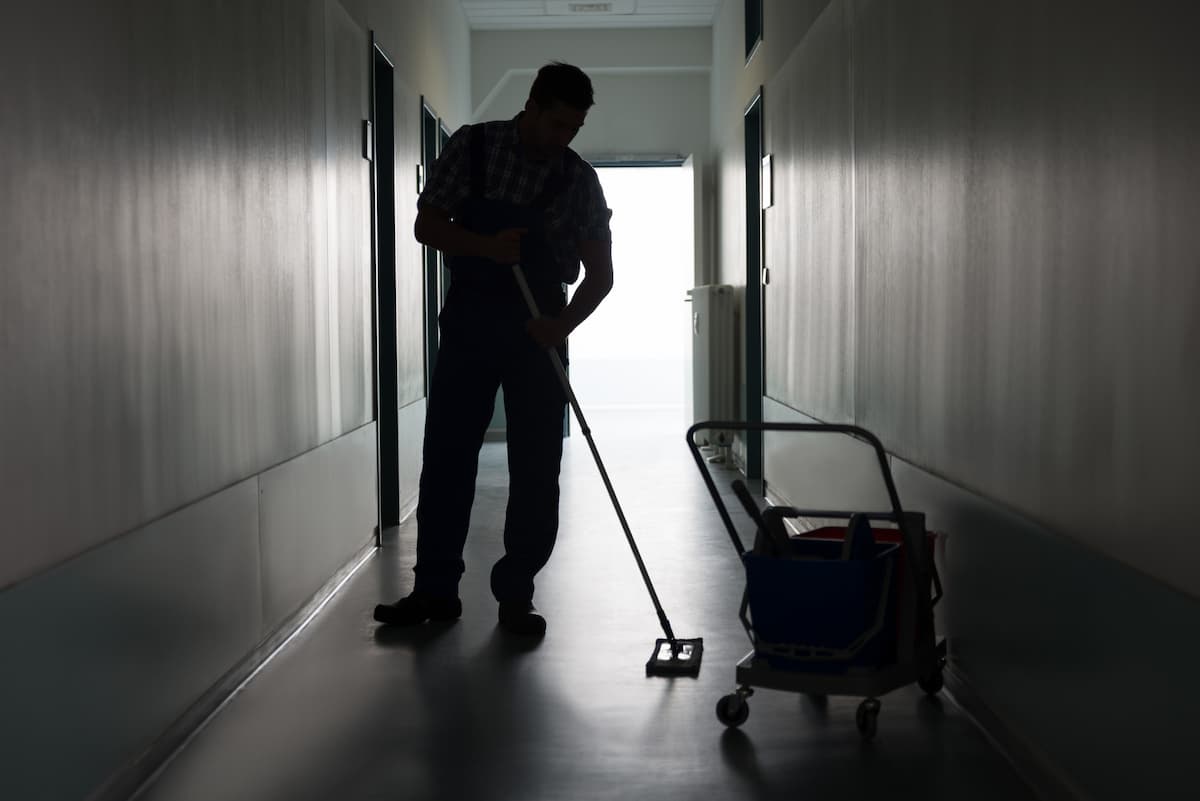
[742,537,900,673]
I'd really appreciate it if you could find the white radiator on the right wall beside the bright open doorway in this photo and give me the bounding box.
[688,284,738,446]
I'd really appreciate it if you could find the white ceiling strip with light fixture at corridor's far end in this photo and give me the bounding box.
[460,0,724,30]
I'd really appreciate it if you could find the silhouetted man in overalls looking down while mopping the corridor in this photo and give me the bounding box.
[374,62,612,637]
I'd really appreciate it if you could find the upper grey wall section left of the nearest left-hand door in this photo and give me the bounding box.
[0,0,371,585]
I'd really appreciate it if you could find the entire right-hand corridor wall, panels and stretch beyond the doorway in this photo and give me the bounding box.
[713,0,1200,799]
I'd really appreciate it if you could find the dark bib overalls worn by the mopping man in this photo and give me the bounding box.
[414,125,566,603]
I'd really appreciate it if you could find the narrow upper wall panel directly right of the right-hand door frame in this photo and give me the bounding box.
[763,5,857,422]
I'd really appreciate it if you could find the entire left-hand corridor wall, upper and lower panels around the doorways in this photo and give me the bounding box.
[0,0,469,800]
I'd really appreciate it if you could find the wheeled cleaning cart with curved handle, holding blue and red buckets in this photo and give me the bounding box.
[688,421,946,740]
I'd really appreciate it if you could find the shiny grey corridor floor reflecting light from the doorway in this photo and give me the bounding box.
[131,412,1034,801]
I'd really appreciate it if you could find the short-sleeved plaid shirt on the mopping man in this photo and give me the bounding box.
[416,112,612,283]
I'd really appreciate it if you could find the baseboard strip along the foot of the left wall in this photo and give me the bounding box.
[86,532,378,801]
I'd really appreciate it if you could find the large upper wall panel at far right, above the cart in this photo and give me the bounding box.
[854,0,1200,594]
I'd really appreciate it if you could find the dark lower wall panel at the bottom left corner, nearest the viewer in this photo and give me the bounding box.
[0,478,263,801]
